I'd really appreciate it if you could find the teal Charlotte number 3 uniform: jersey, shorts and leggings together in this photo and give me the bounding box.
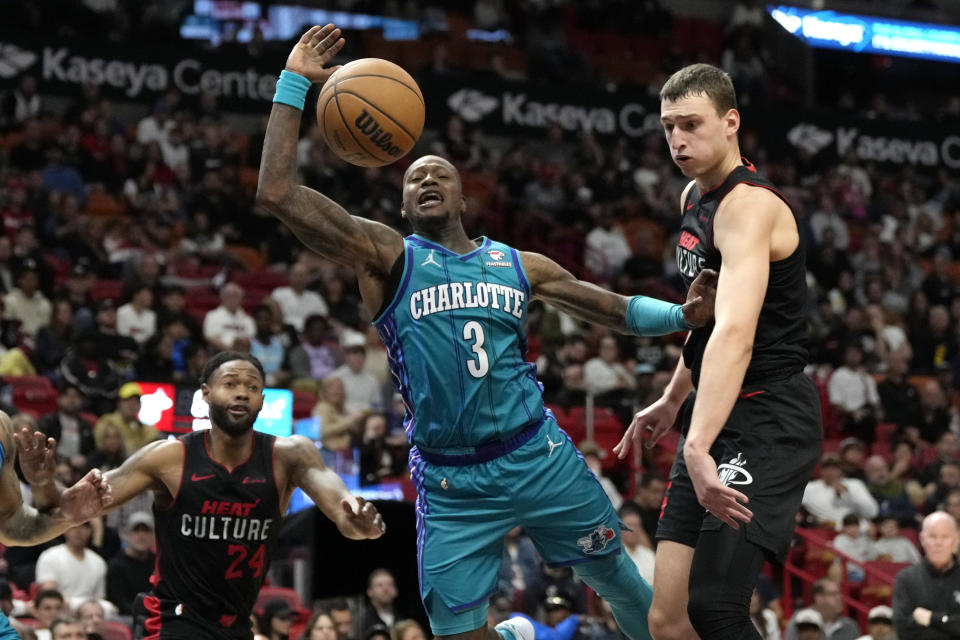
[374,235,651,638]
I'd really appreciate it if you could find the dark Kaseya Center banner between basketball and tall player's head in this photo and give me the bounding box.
[420,77,660,138]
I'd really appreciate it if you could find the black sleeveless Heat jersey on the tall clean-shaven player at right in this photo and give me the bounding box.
[677,159,809,385]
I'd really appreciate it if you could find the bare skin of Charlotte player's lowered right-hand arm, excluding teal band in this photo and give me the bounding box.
[520,251,717,333]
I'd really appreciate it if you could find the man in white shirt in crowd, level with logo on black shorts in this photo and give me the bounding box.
[802,453,880,527]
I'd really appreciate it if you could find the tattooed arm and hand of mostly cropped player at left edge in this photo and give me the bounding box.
[0,412,110,547]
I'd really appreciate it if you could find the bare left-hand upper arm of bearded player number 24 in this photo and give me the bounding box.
[105,440,184,511]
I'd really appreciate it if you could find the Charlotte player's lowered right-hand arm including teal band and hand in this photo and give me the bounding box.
[520,251,717,336]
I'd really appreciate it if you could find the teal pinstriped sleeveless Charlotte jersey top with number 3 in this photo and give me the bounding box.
[374,234,544,451]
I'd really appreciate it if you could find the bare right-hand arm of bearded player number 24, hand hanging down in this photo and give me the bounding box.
[275,436,387,540]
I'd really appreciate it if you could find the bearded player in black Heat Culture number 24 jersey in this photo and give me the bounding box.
[95,352,385,640]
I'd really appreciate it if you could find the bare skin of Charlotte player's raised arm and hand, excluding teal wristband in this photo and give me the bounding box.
[257,25,403,313]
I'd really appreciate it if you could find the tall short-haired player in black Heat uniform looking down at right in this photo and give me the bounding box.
[618,64,822,640]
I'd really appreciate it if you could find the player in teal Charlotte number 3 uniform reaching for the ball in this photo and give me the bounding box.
[257,25,715,640]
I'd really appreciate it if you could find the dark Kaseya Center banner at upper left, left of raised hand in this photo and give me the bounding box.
[0,32,283,111]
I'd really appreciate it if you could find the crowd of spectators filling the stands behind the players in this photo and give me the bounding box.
[0,0,960,640]
